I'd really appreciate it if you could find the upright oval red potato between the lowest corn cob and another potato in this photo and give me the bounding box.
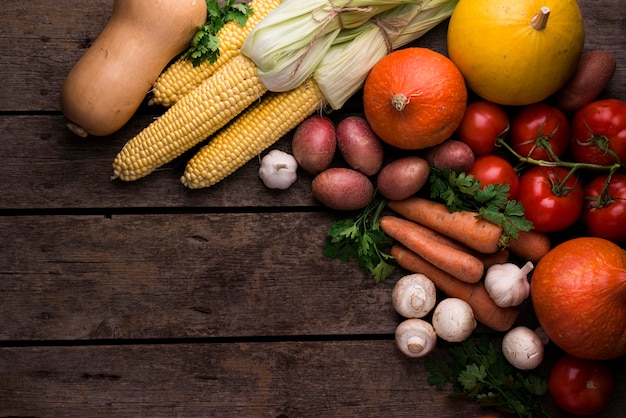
[291,115,337,174]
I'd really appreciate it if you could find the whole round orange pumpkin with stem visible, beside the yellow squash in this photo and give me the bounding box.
[363,47,467,150]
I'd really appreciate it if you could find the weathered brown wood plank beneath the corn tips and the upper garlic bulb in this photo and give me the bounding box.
[0,115,326,210]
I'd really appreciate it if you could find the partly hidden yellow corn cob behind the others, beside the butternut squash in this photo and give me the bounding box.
[150,0,281,107]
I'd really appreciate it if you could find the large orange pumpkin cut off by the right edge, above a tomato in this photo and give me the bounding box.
[530,237,626,360]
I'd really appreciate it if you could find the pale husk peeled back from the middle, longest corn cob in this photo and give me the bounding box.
[241,0,424,91]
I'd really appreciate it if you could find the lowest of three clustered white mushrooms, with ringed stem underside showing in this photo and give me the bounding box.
[396,318,437,358]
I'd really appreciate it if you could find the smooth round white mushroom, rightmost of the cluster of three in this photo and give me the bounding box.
[433,298,476,343]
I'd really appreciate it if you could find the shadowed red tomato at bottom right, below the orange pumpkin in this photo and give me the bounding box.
[548,354,614,415]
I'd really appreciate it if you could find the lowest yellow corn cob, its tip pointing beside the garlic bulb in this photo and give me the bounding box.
[180,79,325,189]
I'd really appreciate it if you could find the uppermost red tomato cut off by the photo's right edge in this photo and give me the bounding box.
[570,99,626,165]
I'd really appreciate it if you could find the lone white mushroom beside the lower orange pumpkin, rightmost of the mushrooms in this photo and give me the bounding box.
[502,326,544,370]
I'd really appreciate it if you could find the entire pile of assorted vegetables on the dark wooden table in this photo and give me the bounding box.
[61,0,626,417]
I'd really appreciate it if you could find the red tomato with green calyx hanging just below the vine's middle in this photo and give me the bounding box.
[517,166,584,232]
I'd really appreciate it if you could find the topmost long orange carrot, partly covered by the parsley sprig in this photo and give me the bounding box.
[387,197,502,254]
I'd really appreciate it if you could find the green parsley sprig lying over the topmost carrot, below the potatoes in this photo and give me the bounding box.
[429,166,533,238]
